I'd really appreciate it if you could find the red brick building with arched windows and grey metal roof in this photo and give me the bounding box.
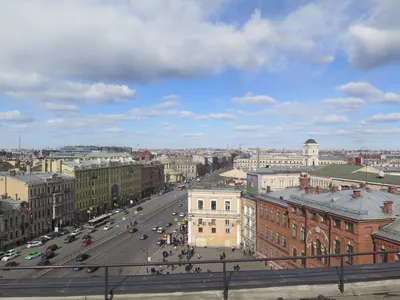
[256,179,400,268]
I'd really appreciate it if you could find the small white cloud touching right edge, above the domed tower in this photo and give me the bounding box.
[337,82,400,104]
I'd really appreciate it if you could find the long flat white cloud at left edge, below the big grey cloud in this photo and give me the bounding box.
[0,72,136,103]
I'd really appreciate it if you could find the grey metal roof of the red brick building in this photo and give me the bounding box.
[288,189,400,221]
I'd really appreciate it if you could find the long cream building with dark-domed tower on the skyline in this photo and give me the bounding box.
[233,139,320,170]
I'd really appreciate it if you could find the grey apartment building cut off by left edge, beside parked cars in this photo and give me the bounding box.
[0,195,31,251]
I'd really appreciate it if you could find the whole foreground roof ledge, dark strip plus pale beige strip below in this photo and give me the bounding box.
[0,263,400,299]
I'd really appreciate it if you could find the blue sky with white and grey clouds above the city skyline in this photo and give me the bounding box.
[0,0,400,149]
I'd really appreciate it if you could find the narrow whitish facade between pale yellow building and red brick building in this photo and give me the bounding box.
[240,193,257,255]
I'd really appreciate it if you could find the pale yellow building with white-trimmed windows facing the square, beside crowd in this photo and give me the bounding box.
[188,189,242,248]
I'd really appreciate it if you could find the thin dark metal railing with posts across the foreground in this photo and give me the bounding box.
[0,250,400,300]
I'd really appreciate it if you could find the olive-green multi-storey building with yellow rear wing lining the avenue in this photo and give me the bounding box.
[42,159,142,220]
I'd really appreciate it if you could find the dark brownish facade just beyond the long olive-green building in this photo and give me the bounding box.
[142,162,165,197]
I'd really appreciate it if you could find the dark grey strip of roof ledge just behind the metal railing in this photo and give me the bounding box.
[0,263,400,297]
